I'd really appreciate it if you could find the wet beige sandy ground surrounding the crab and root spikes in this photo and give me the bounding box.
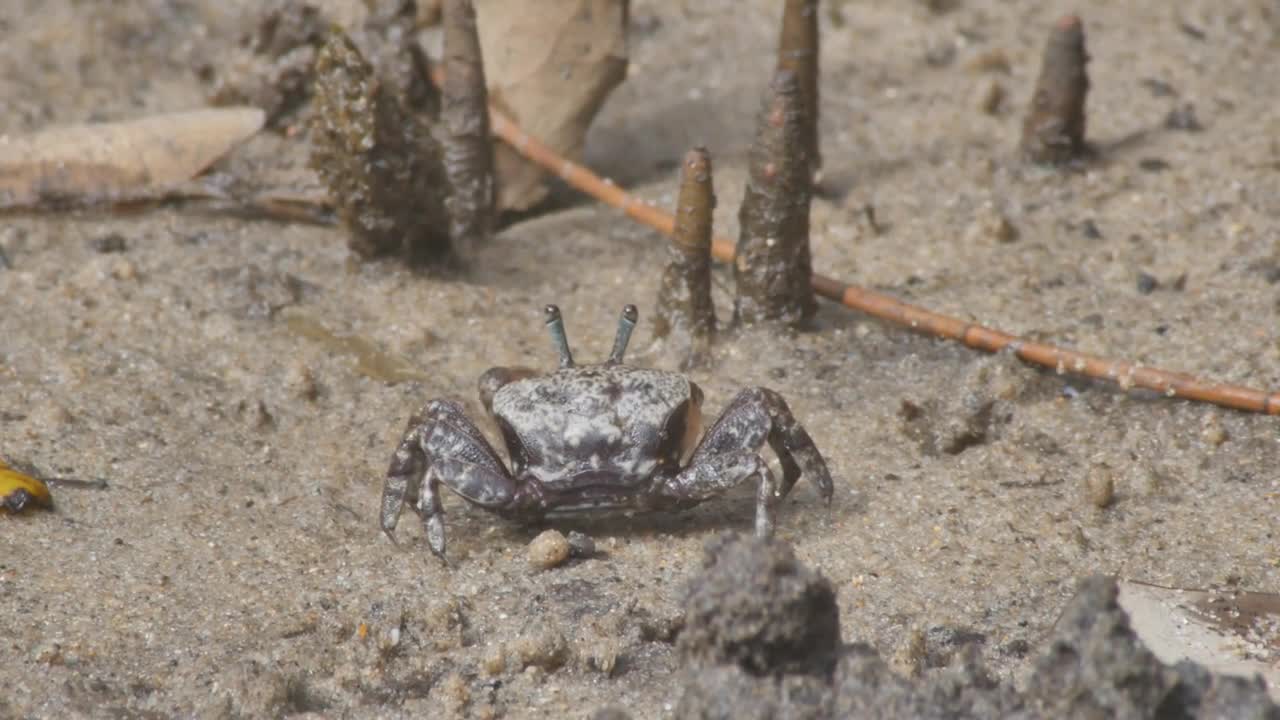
[0,0,1280,717]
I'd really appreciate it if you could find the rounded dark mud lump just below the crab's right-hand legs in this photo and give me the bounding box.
[677,537,840,676]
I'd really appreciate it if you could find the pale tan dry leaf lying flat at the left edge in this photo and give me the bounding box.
[0,108,264,209]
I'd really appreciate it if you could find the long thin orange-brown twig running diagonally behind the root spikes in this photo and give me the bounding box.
[445,69,1280,415]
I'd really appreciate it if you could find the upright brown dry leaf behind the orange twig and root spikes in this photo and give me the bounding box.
[475,0,627,210]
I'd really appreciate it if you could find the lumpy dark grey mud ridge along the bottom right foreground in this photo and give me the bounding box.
[675,539,1280,720]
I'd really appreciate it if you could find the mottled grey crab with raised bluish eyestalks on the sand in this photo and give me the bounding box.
[379,299,833,560]
